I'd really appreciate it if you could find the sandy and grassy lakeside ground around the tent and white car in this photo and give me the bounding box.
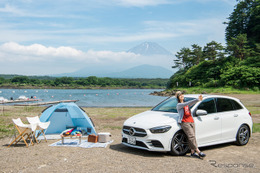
[0,94,260,172]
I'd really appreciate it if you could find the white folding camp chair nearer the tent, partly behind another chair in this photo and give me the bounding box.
[26,116,50,143]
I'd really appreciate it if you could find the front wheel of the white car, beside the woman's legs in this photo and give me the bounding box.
[170,131,189,156]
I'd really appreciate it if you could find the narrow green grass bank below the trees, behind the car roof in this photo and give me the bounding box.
[166,87,260,94]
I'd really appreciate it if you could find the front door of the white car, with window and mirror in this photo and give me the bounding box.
[194,98,221,146]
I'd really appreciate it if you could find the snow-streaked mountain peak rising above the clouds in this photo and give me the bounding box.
[127,42,172,56]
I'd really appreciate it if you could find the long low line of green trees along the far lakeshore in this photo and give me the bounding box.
[0,76,168,88]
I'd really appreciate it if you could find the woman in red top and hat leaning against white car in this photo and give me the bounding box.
[175,91,206,158]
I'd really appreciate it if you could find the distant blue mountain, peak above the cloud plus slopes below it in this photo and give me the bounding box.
[52,42,174,78]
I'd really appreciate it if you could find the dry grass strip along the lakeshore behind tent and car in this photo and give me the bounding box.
[0,103,260,138]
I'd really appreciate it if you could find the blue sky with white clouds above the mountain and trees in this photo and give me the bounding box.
[0,0,236,75]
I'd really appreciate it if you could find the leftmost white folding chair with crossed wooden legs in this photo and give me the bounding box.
[8,118,35,147]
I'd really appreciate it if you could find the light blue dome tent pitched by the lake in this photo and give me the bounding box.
[40,103,96,135]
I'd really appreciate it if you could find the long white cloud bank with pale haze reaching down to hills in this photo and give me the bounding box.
[0,42,172,75]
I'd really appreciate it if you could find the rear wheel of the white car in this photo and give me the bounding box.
[236,124,250,146]
